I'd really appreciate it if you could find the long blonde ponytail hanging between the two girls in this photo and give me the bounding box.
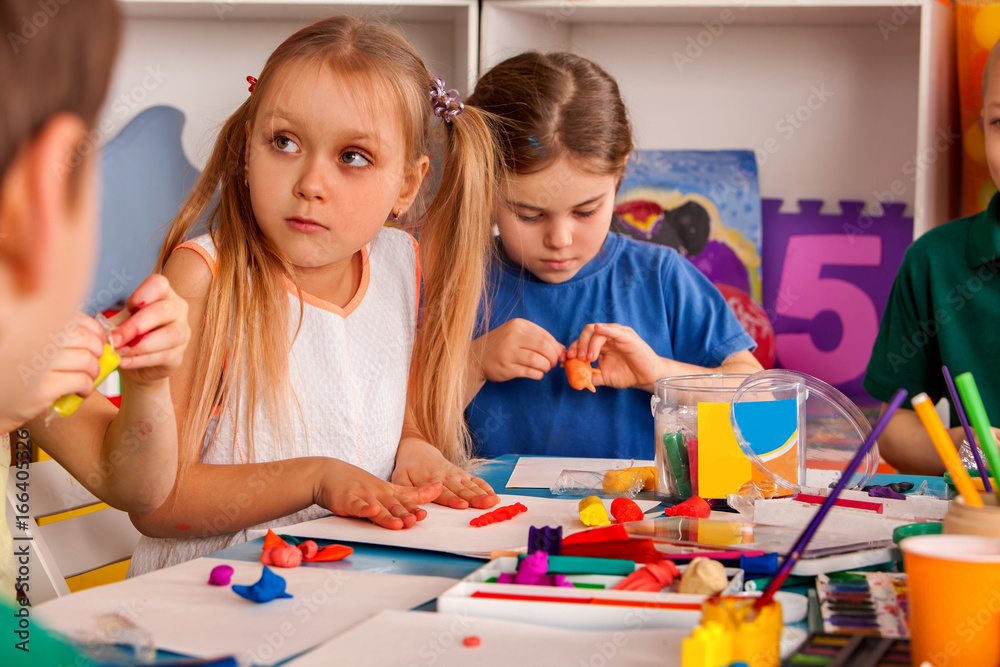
[409,105,500,465]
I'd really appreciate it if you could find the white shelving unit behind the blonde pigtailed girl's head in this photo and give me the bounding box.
[108,0,479,168]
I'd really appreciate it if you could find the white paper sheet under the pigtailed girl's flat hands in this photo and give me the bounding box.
[278,495,659,558]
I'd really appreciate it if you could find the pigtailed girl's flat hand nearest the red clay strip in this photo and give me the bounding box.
[392,437,500,510]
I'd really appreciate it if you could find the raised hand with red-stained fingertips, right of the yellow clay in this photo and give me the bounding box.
[111,273,191,384]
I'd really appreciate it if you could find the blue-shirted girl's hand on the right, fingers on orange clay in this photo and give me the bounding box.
[566,324,660,389]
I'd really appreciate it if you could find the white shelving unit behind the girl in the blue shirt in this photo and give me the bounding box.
[480,0,960,235]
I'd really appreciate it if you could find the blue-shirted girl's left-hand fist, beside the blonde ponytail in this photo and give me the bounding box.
[472,318,565,382]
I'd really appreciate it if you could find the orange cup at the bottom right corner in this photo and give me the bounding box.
[899,535,1000,667]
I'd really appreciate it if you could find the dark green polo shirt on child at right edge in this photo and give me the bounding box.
[864,194,1000,426]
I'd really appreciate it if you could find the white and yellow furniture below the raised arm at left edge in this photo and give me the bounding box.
[7,459,140,605]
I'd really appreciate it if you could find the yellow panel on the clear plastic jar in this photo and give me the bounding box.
[698,403,751,498]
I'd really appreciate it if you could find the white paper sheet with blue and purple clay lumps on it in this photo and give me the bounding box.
[32,558,456,665]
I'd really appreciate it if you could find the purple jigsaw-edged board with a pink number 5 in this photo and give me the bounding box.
[761,199,913,397]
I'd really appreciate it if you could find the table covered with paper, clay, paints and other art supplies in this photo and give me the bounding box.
[27,371,1000,667]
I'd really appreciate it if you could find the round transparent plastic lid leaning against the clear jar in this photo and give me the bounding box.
[730,369,879,493]
